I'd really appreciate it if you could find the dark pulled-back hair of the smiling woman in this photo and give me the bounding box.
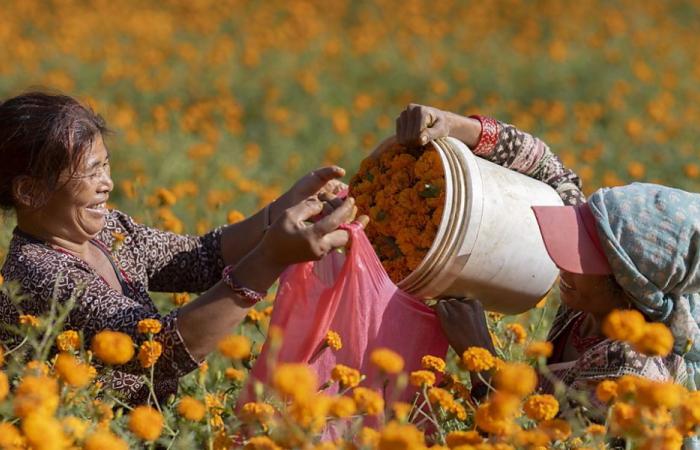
[0,92,107,209]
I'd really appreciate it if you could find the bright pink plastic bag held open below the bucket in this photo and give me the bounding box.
[252,224,448,400]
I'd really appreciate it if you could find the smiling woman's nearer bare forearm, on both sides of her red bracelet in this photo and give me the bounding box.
[177,251,284,361]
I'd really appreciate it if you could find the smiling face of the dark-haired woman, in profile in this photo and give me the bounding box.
[36,135,114,242]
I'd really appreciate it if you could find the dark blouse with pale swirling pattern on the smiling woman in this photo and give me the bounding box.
[0,210,224,404]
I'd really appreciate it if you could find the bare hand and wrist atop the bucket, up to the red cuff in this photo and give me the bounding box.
[396,103,481,148]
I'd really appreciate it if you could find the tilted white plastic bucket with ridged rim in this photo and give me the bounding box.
[373,137,562,314]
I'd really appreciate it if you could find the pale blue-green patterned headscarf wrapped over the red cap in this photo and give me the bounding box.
[588,183,700,389]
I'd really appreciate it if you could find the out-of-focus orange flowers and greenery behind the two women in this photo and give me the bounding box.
[0,0,700,448]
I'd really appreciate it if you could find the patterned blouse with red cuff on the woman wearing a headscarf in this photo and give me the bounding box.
[474,116,687,414]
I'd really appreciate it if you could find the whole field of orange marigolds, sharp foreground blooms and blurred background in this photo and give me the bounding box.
[0,0,700,450]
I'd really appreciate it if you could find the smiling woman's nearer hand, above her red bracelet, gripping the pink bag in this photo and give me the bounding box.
[260,196,367,267]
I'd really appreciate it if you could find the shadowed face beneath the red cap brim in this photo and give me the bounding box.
[559,271,626,317]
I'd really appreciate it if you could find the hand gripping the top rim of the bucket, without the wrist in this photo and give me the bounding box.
[396,103,450,147]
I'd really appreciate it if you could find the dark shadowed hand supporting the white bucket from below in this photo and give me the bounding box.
[435,299,495,356]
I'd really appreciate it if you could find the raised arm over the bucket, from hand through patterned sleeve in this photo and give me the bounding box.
[396,104,585,205]
